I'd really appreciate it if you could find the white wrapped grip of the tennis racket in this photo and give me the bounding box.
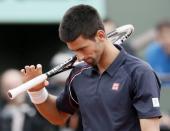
[8,74,47,99]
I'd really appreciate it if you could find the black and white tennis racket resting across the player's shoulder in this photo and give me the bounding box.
[8,25,134,99]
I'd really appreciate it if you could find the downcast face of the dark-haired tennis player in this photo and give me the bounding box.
[67,36,102,66]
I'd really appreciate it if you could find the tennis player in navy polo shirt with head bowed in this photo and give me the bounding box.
[21,5,161,131]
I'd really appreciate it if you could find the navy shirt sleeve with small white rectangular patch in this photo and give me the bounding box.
[132,67,161,119]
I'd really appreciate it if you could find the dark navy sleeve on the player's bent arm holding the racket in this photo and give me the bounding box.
[56,69,78,114]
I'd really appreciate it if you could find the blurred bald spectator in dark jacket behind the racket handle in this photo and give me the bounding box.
[0,69,58,131]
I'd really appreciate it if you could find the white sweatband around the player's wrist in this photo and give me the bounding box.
[27,87,48,104]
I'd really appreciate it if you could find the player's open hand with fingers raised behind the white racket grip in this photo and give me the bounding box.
[21,64,49,92]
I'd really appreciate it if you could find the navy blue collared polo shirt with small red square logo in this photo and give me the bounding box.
[57,46,161,131]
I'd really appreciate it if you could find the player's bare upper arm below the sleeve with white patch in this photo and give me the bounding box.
[140,117,160,131]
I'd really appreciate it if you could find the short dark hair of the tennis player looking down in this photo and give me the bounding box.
[59,4,104,42]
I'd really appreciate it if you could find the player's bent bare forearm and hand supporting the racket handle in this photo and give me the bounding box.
[21,65,69,125]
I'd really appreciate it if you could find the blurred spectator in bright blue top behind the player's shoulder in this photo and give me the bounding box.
[146,21,170,85]
